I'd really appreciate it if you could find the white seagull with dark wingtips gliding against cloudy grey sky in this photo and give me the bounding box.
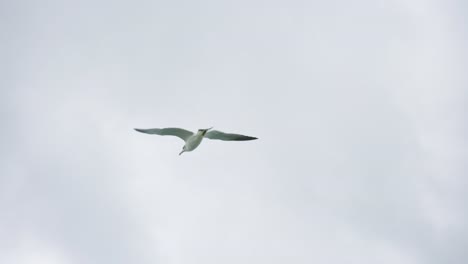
[135,127,257,156]
